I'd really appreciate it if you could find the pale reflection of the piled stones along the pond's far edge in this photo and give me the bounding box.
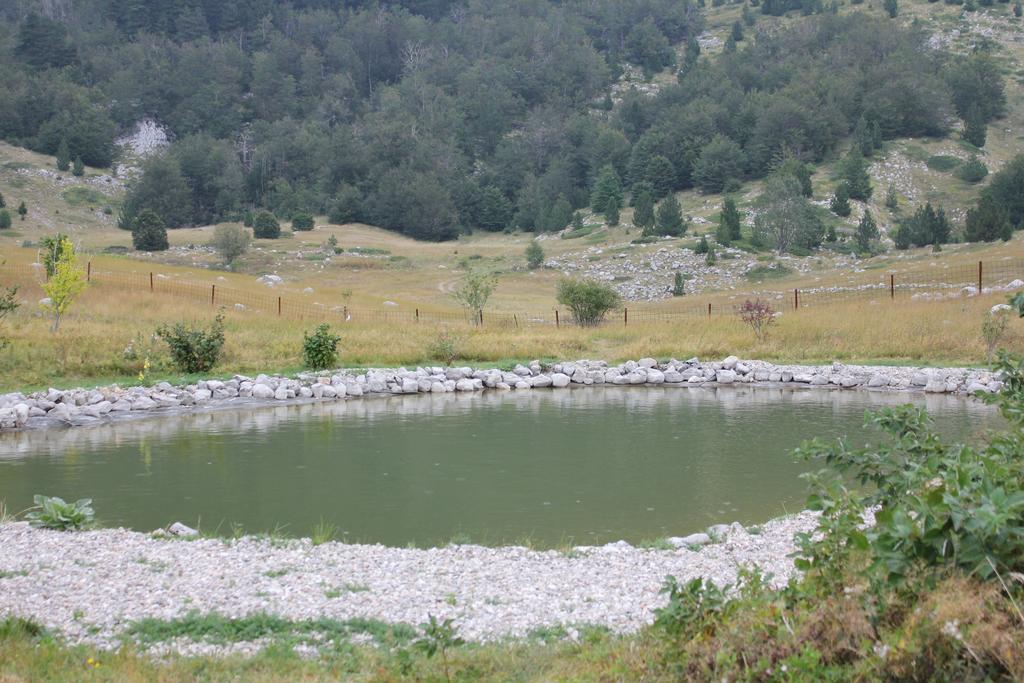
[0,385,995,459]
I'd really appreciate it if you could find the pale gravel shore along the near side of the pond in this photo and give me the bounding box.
[0,512,816,655]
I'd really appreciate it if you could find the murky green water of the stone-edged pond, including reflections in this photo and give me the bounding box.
[0,387,997,546]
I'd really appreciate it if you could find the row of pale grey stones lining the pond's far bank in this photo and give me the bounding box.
[0,355,1002,431]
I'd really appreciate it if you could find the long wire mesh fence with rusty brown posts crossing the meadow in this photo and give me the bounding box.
[0,258,1024,328]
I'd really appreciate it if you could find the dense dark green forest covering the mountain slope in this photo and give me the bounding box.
[0,0,1006,240]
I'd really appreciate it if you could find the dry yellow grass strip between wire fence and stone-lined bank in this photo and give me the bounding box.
[0,264,1024,390]
